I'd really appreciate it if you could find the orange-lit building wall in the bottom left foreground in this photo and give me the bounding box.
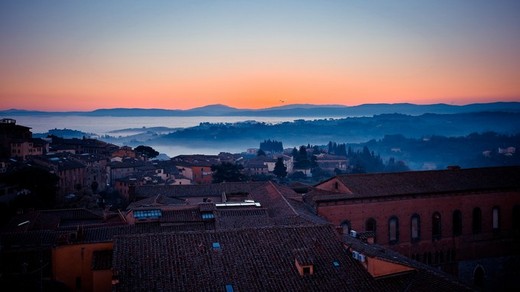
[52,242,113,291]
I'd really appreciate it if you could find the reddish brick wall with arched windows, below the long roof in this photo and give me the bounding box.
[317,189,520,265]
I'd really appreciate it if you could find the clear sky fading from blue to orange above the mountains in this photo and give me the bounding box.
[0,0,520,111]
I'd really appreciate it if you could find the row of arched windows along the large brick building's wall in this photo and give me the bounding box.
[341,205,520,244]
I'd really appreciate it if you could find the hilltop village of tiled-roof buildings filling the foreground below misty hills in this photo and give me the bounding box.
[0,119,520,291]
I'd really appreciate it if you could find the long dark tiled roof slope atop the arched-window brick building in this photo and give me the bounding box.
[317,166,520,198]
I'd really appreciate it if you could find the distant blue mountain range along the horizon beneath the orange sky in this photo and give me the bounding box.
[0,102,520,117]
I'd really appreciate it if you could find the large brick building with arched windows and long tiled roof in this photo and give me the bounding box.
[305,167,520,288]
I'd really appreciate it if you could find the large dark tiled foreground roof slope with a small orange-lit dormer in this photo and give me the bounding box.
[113,225,385,291]
